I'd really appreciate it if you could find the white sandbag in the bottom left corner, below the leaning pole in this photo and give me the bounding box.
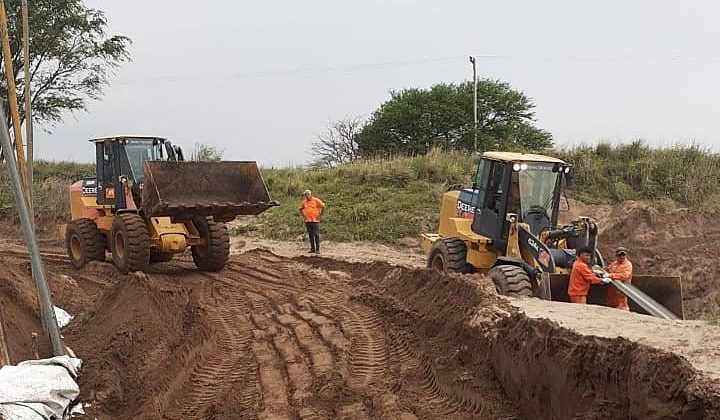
[0,356,82,420]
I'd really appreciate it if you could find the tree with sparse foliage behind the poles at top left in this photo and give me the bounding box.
[0,0,131,125]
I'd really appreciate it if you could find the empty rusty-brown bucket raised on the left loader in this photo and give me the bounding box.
[142,161,278,222]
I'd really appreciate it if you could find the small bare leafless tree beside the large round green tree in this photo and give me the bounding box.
[312,116,365,167]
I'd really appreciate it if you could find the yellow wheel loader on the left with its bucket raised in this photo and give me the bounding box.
[59,136,277,272]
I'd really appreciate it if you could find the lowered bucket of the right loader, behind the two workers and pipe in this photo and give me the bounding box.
[550,274,685,319]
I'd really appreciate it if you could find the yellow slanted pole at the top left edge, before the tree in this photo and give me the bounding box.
[0,0,30,199]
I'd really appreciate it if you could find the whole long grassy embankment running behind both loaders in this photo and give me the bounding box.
[0,142,720,243]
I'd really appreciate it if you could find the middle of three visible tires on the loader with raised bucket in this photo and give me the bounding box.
[110,213,150,273]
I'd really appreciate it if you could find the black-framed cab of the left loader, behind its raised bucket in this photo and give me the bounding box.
[90,136,183,210]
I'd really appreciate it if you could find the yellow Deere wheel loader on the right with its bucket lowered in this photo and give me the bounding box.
[422,152,683,319]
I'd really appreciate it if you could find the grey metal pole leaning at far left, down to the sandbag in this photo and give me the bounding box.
[0,100,65,356]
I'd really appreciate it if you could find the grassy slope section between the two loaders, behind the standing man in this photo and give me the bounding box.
[261,150,474,243]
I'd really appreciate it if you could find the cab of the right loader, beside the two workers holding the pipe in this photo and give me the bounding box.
[472,152,570,251]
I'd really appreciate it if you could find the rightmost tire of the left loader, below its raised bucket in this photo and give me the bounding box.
[192,217,230,271]
